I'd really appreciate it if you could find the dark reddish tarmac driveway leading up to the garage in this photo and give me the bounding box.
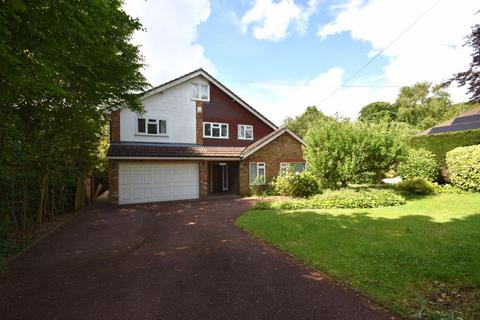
[0,199,390,320]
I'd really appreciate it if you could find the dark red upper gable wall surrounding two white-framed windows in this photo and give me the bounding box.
[202,83,273,147]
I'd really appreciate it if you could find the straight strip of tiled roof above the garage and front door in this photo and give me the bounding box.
[108,142,245,158]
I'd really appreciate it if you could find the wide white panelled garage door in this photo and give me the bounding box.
[118,163,199,204]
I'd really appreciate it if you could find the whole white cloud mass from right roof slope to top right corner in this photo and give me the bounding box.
[241,0,479,124]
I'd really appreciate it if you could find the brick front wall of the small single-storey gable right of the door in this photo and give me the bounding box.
[240,133,305,196]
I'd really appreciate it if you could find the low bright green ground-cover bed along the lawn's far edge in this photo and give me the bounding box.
[253,189,405,210]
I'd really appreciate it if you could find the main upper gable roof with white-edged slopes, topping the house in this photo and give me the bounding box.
[140,68,278,130]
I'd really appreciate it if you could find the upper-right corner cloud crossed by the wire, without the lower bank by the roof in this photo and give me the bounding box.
[318,0,479,94]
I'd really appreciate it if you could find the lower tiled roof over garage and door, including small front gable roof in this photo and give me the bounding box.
[107,127,304,160]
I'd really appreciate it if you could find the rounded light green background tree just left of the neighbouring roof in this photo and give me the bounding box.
[396,82,452,129]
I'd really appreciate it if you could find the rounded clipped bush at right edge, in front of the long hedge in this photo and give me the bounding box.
[447,145,480,192]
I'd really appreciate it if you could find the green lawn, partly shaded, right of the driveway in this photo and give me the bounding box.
[237,194,480,319]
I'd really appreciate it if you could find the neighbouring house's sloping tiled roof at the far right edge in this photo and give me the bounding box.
[417,107,480,136]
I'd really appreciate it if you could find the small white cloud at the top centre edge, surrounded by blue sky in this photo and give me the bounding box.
[240,0,317,41]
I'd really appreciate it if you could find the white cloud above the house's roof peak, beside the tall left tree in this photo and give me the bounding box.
[124,0,216,86]
